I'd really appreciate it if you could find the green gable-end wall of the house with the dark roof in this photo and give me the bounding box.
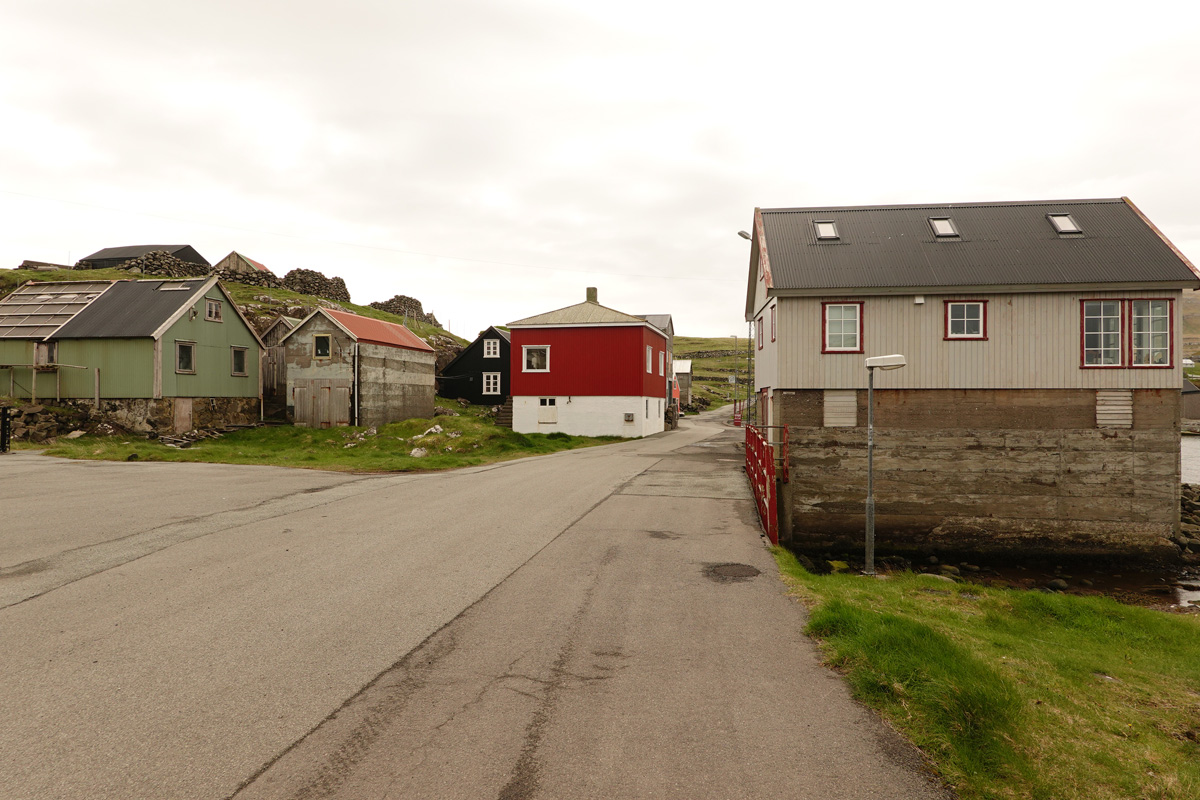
[162,287,260,397]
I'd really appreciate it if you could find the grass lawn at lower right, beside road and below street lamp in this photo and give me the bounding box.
[775,548,1200,800]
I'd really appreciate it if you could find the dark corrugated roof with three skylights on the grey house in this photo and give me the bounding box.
[762,198,1200,289]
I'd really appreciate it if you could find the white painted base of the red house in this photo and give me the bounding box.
[512,396,665,438]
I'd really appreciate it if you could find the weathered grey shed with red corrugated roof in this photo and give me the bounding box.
[281,308,436,428]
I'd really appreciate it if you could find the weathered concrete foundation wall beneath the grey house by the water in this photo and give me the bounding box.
[775,390,1180,558]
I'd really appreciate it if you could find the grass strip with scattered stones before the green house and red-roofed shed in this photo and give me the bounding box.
[30,414,623,473]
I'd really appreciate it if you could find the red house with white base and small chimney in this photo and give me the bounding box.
[509,288,671,437]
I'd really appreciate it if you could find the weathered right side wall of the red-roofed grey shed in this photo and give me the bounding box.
[359,343,437,425]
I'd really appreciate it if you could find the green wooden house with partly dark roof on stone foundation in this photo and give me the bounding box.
[0,277,263,432]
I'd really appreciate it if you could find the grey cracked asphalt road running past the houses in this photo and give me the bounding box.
[0,412,942,800]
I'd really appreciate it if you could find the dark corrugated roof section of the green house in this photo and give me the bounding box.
[54,278,205,339]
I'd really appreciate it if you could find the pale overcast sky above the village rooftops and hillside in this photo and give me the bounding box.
[0,0,1200,338]
